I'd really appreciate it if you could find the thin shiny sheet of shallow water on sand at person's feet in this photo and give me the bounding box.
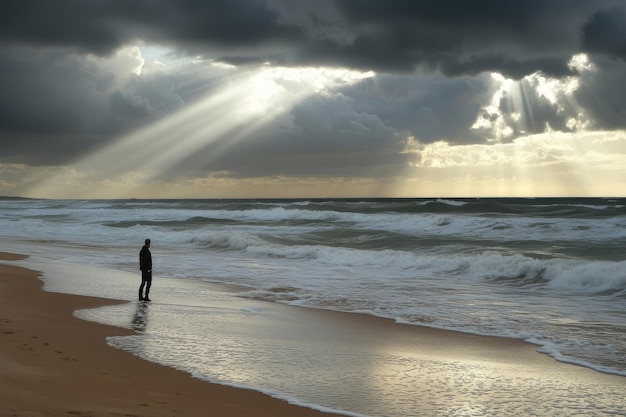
[22,258,626,417]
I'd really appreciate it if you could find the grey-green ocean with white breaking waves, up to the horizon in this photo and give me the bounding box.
[0,198,626,412]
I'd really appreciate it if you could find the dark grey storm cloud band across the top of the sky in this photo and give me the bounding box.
[0,0,625,78]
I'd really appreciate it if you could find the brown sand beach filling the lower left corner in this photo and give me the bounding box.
[0,252,342,417]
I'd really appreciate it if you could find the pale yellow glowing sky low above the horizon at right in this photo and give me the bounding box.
[403,131,626,197]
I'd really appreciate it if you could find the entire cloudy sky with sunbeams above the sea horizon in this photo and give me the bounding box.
[0,0,626,199]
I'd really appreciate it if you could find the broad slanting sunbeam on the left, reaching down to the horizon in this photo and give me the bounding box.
[27,64,373,198]
